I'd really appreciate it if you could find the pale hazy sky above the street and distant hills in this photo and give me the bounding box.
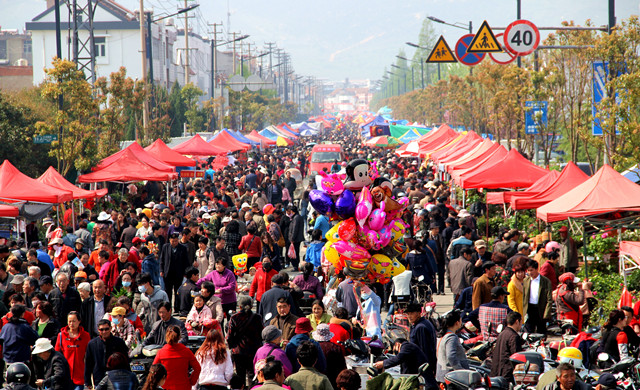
[0,0,640,80]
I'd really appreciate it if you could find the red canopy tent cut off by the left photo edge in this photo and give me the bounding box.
[0,160,73,203]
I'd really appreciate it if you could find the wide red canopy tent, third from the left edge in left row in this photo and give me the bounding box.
[78,149,178,183]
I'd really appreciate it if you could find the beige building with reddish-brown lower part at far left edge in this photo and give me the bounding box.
[0,30,33,90]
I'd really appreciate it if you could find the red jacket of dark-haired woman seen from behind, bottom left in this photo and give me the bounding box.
[153,343,200,390]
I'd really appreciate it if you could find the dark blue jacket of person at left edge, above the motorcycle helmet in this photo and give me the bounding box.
[0,318,38,363]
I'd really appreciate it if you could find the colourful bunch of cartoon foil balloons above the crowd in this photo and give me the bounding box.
[309,159,409,284]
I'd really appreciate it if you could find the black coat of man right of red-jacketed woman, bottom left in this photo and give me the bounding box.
[84,336,129,386]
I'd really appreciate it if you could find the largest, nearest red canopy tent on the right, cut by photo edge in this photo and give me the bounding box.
[536,165,640,222]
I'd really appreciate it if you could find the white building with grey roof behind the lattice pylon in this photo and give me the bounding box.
[26,0,176,85]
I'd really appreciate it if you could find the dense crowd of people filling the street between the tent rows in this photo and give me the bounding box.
[0,125,620,390]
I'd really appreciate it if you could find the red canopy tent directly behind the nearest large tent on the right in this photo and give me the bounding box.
[511,162,589,210]
